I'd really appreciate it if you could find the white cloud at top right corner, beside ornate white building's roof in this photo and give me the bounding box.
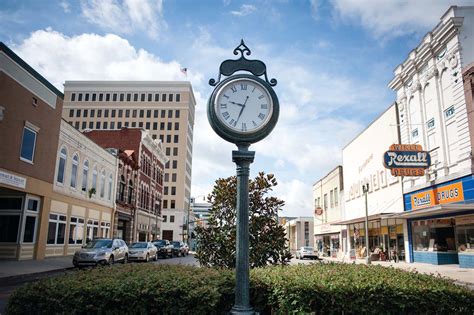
[331,0,472,37]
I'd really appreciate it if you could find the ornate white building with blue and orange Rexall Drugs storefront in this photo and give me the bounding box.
[389,6,474,268]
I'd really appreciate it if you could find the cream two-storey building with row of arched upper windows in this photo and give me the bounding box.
[50,120,118,257]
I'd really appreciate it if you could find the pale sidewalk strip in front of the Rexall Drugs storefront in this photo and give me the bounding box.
[323,257,474,289]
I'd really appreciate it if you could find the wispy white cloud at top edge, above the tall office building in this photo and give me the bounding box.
[81,0,166,39]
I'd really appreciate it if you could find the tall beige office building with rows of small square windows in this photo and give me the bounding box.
[63,81,196,240]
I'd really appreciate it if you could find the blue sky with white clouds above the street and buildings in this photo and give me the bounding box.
[0,0,470,216]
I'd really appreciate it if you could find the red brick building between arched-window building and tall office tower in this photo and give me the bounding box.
[84,128,169,241]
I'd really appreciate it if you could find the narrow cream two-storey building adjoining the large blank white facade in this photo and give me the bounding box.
[313,165,347,257]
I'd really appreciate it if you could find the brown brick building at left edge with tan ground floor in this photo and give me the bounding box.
[0,42,63,260]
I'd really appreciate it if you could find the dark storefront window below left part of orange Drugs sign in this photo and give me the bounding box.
[412,218,456,252]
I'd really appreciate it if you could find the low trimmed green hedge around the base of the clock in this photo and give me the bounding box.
[6,264,474,314]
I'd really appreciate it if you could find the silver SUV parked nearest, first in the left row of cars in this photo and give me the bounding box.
[72,238,129,267]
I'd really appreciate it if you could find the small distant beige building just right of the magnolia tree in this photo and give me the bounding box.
[280,217,314,253]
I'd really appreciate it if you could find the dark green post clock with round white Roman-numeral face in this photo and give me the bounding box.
[207,40,280,314]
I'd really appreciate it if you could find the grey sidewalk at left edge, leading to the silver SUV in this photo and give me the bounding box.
[0,256,73,283]
